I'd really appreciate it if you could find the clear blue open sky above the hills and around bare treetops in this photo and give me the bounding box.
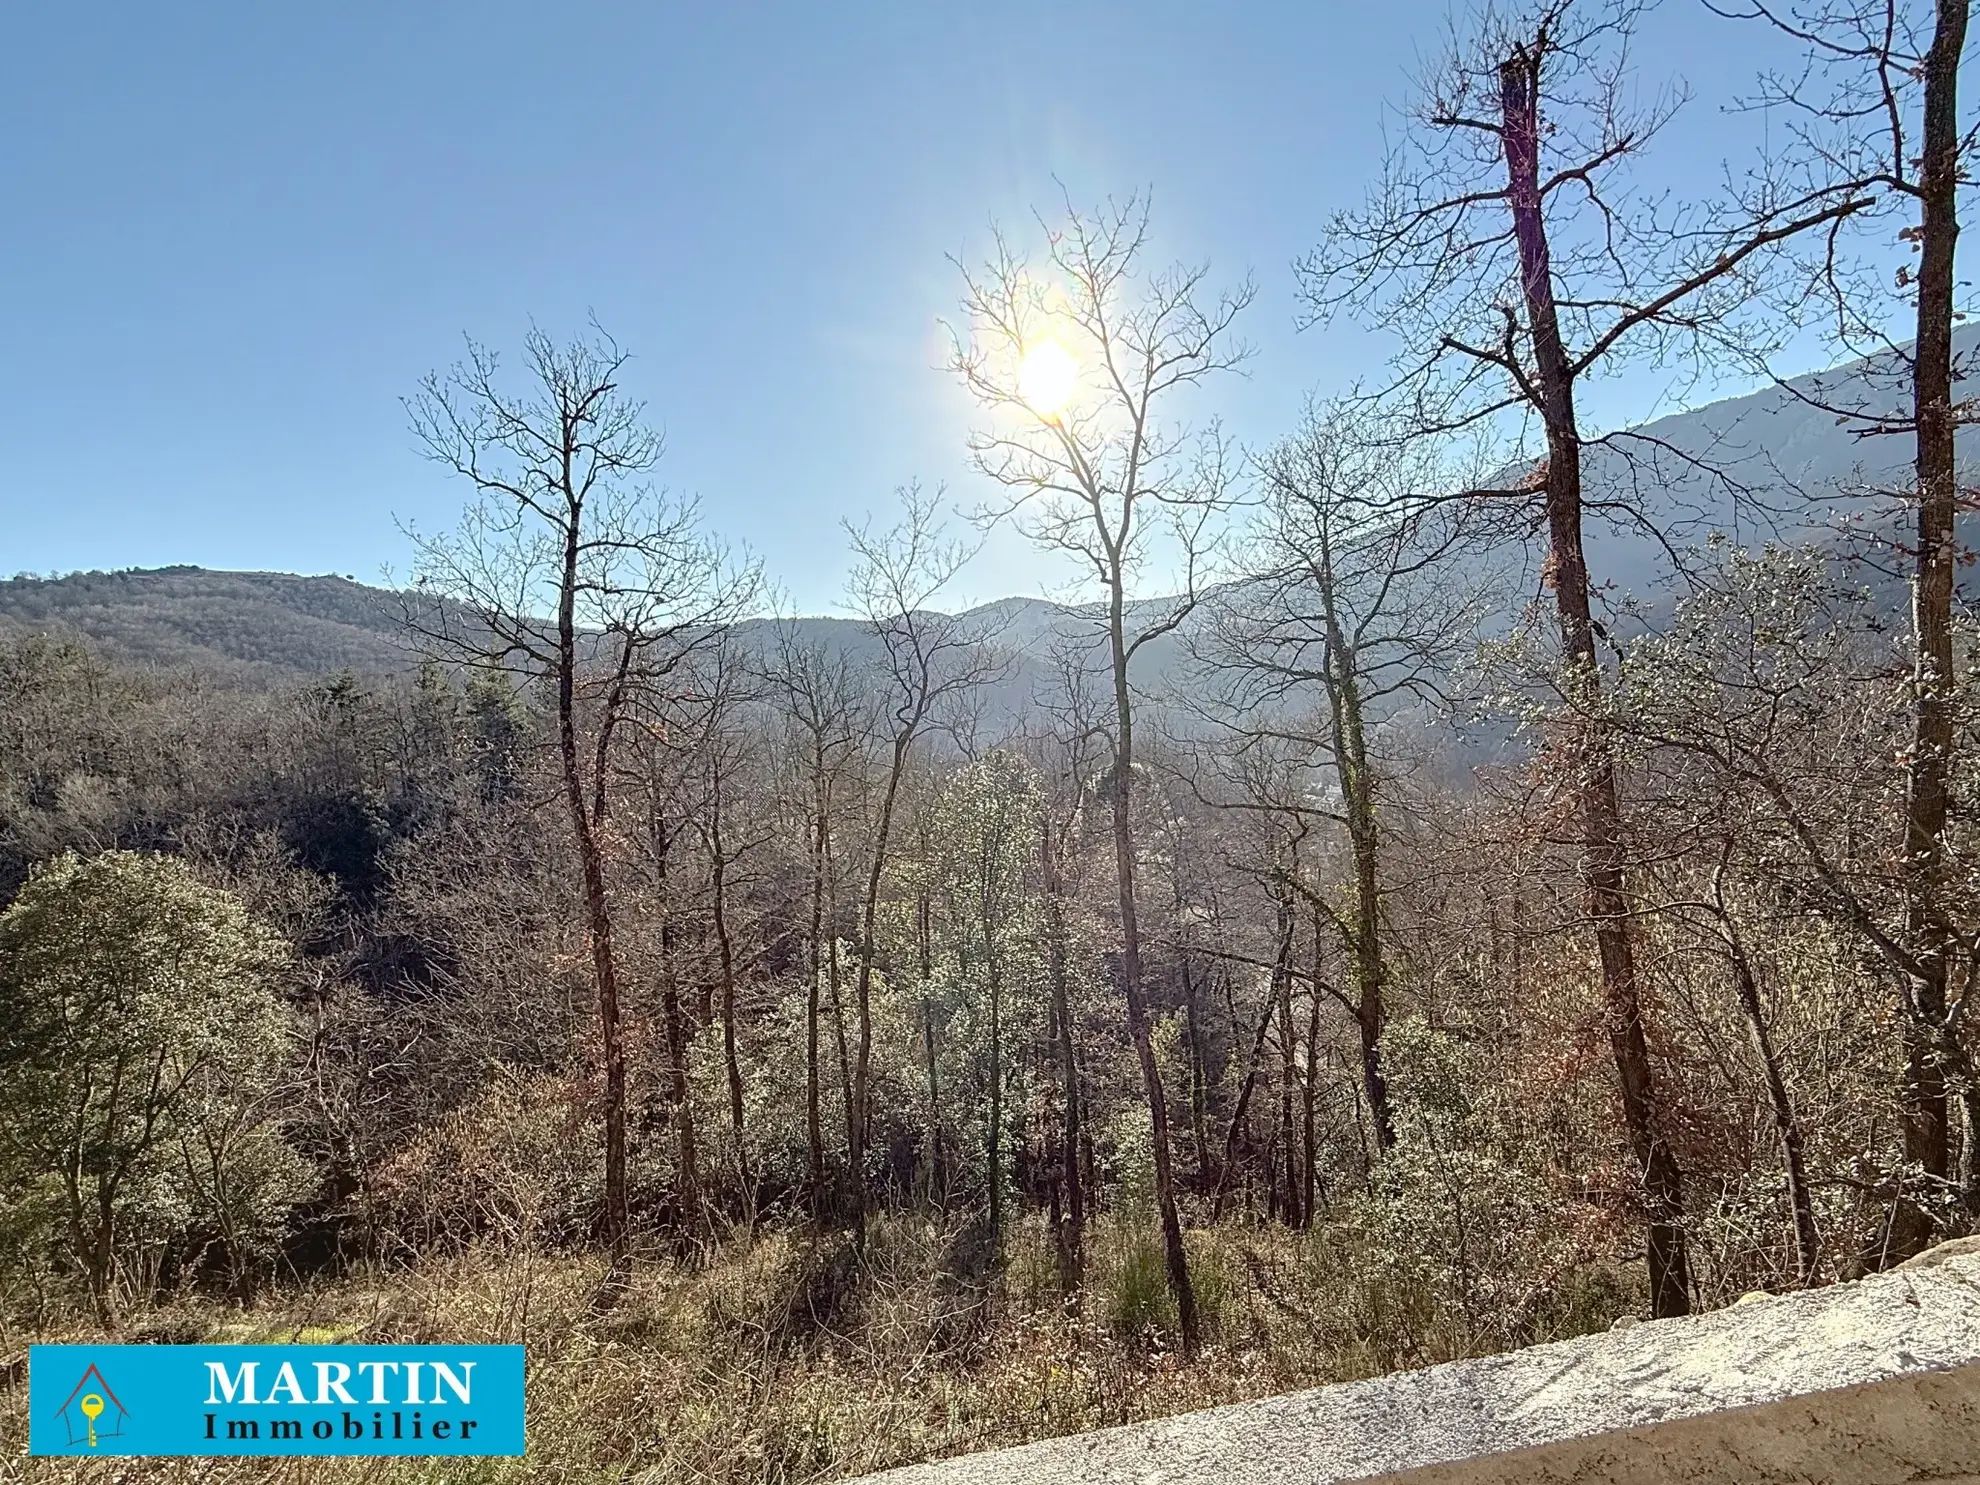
[0,0,1821,612]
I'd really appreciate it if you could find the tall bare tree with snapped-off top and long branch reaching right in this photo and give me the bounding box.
[1303,0,1867,1315]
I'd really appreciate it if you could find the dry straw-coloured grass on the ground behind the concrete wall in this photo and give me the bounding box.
[0,1218,1631,1485]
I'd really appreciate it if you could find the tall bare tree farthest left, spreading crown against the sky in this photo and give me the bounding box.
[408,325,754,1283]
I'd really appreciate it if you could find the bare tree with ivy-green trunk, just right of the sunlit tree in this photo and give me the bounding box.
[1192,402,1491,1152]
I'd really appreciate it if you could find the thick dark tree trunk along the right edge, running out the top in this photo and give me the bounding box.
[1889,0,1968,1259]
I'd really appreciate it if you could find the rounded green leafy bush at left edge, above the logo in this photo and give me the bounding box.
[0,851,307,1317]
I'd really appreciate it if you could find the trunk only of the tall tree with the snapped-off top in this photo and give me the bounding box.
[1499,50,1691,1319]
